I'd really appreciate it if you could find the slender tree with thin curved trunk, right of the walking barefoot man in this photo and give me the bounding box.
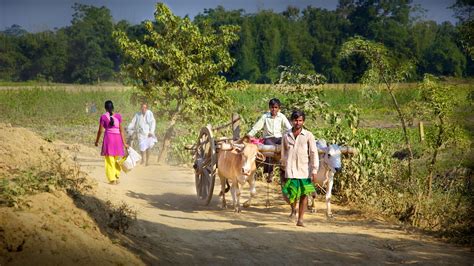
[341,37,413,178]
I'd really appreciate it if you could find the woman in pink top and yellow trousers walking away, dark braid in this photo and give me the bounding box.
[95,101,128,184]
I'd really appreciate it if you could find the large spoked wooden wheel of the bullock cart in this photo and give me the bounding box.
[194,125,217,205]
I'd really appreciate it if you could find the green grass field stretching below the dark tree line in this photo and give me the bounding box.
[0,83,474,143]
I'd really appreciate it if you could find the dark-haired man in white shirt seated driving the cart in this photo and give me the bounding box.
[247,98,291,183]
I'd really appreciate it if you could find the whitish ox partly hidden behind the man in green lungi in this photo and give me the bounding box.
[308,140,354,217]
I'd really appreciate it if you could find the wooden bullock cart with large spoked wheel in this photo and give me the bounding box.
[185,114,280,205]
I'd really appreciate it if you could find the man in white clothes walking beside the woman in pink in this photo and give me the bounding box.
[127,103,157,165]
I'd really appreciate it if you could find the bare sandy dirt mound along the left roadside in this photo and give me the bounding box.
[0,124,143,265]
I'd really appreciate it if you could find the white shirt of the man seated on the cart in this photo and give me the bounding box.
[248,112,291,138]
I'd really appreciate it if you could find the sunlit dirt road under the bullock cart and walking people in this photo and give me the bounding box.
[78,149,474,265]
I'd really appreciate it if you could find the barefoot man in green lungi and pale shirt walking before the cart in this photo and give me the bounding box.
[281,111,319,226]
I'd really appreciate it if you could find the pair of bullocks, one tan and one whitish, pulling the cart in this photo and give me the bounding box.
[217,137,353,216]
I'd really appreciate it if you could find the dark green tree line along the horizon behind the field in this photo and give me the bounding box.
[0,0,474,83]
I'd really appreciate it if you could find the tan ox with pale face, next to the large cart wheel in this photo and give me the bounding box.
[217,138,265,212]
